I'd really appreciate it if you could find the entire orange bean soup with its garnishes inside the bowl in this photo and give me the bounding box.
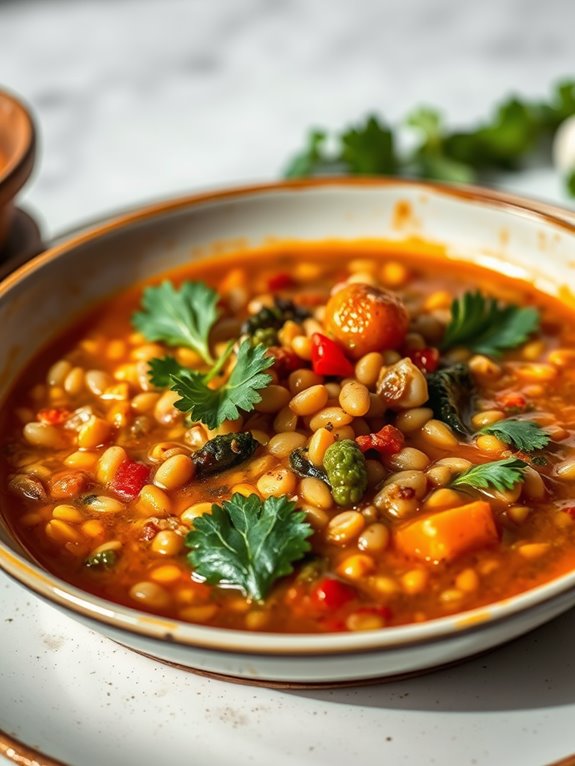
[0,244,575,632]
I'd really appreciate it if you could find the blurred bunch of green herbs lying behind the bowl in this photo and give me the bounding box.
[285,80,575,196]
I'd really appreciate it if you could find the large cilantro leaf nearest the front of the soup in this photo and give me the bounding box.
[186,493,313,601]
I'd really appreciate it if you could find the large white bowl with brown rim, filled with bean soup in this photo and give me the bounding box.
[0,179,575,684]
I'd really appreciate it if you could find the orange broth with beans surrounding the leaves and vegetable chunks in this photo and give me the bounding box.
[0,246,575,632]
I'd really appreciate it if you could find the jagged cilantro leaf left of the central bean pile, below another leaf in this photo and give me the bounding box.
[170,340,274,428]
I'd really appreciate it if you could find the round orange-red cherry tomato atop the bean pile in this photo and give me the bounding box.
[325,283,409,359]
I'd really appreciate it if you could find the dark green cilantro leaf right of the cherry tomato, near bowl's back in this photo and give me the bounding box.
[441,291,539,356]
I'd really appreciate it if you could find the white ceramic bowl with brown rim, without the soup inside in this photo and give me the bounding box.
[0,179,575,684]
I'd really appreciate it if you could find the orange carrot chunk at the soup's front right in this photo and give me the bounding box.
[394,500,499,562]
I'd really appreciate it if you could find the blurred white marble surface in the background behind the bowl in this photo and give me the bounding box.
[0,0,575,240]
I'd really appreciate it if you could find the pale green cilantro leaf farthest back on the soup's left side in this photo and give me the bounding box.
[132,282,218,364]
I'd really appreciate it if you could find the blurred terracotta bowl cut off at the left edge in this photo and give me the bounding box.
[0,90,35,252]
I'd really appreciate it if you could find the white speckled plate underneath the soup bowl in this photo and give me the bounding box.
[0,574,575,766]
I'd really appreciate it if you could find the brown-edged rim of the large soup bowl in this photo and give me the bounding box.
[0,177,575,657]
